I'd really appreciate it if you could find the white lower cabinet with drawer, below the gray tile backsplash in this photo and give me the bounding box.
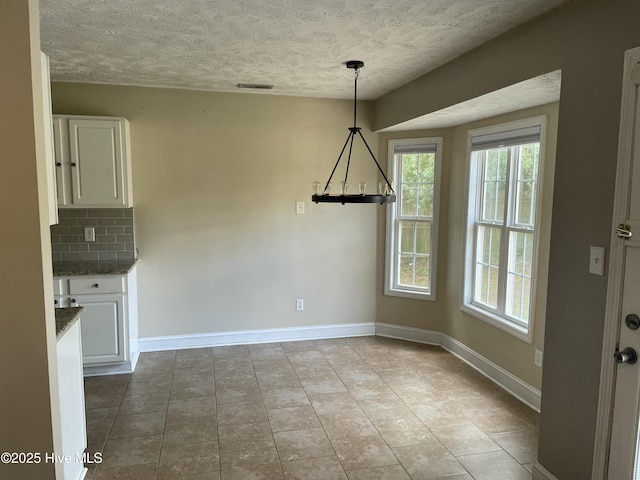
[56,268,139,376]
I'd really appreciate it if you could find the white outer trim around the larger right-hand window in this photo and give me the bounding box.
[460,115,547,343]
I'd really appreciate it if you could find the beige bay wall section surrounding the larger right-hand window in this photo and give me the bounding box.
[444,104,558,389]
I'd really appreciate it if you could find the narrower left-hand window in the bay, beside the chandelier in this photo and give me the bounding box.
[385,138,442,300]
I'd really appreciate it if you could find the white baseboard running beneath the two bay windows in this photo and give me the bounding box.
[376,323,541,412]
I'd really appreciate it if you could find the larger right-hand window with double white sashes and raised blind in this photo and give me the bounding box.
[463,118,544,340]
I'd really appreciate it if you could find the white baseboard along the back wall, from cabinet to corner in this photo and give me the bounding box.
[138,322,376,352]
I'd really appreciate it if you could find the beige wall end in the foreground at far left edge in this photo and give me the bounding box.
[0,0,61,480]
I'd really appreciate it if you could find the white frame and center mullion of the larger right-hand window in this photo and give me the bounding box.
[460,115,547,343]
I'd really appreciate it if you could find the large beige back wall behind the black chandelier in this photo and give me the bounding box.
[52,84,378,337]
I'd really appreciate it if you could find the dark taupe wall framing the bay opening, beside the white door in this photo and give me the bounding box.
[374,0,640,480]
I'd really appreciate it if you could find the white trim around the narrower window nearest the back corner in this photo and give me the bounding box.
[384,137,442,301]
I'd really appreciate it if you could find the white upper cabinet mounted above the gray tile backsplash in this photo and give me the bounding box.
[53,115,133,208]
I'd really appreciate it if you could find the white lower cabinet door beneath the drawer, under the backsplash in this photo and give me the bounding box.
[72,295,127,365]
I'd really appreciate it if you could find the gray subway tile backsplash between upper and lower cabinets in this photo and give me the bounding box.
[51,208,135,262]
